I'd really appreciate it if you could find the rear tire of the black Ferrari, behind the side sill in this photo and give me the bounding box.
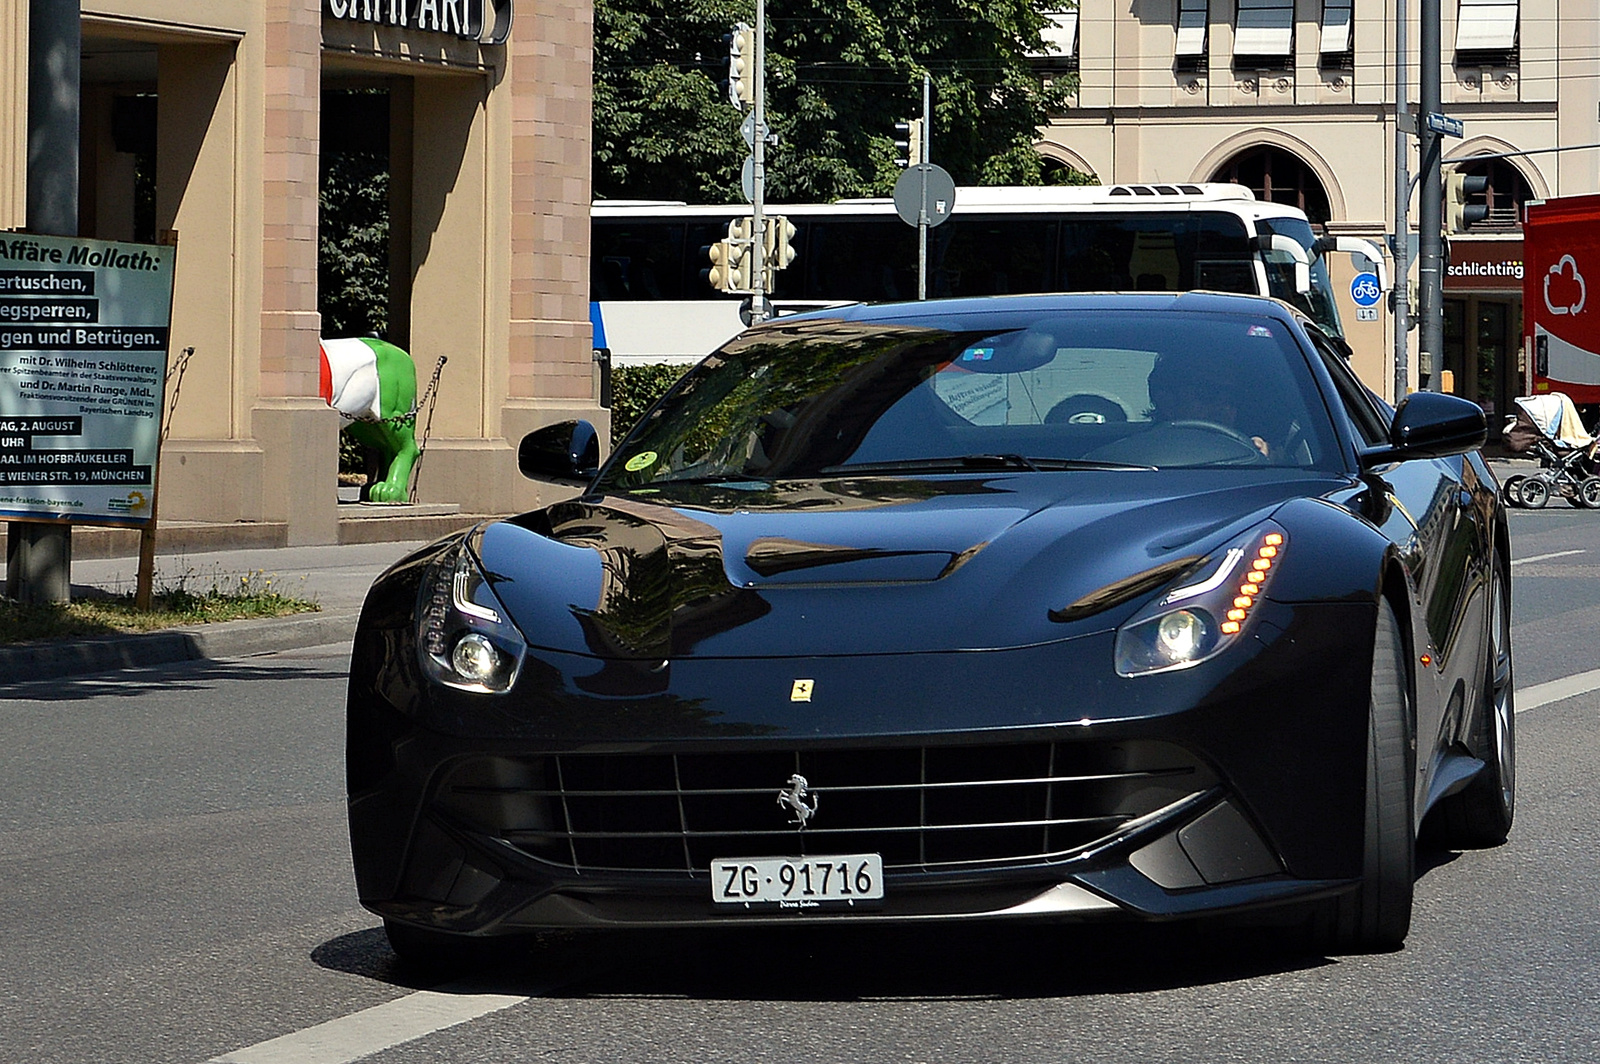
[1426,558,1517,850]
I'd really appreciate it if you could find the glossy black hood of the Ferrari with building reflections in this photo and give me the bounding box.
[474,469,1349,661]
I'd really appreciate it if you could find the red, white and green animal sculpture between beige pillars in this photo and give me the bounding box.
[320,338,422,502]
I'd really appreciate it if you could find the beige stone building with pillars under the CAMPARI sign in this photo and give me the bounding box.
[0,0,605,544]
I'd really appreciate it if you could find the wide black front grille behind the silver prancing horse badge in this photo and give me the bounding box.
[437,742,1214,875]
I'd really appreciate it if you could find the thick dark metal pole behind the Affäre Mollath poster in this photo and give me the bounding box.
[5,0,83,603]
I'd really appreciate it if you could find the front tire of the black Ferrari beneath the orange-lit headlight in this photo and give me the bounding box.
[1315,598,1416,954]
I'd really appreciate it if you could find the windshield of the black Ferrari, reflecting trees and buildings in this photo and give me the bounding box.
[597,310,1339,490]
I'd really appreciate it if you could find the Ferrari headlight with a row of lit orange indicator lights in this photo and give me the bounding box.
[1115,522,1288,677]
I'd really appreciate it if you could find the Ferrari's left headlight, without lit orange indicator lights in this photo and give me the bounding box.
[416,541,528,694]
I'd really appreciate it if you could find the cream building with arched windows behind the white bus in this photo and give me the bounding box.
[1040,0,1600,413]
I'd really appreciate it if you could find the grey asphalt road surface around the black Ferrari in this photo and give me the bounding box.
[0,506,1600,1064]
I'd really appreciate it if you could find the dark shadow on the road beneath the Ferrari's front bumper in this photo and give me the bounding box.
[312,923,1334,1002]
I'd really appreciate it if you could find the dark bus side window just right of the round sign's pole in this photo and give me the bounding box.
[912,216,1056,298]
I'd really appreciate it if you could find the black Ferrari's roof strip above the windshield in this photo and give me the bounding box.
[770,291,1301,323]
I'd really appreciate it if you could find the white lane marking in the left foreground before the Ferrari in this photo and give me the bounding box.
[206,990,528,1064]
